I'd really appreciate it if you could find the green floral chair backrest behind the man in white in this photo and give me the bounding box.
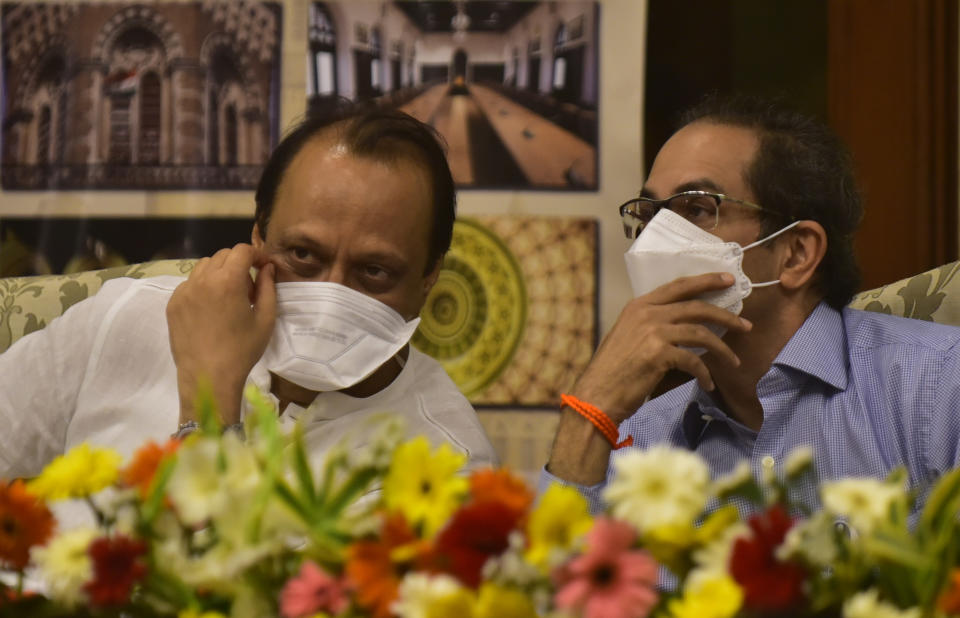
[0,260,196,352]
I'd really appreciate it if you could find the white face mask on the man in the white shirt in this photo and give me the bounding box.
[263,281,420,391]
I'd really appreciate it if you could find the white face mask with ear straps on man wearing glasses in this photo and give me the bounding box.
[624,208,799,335]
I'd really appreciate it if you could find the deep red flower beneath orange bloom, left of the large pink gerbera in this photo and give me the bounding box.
[433,502,523,588]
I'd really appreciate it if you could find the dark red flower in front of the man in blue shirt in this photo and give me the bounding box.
[730,504,805,611]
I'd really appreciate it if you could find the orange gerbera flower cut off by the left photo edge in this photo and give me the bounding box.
[0,480,55,571]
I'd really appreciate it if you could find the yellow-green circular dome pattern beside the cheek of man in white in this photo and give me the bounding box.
[413,219,527,397]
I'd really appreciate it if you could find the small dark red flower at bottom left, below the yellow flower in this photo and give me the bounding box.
[83,534,147,606]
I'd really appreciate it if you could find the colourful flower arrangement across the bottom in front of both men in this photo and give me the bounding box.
[0,390,960,618]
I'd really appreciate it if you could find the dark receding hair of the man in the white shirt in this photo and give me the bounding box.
[254,104,457,272]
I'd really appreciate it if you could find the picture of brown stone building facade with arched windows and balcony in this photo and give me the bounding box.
[0,0,281,190]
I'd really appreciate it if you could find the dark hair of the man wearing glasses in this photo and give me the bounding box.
[680,94,863,309]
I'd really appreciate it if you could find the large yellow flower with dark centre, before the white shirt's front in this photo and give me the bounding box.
[383,436,468,537]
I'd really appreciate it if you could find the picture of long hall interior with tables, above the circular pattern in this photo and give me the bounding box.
[306,0,600,190]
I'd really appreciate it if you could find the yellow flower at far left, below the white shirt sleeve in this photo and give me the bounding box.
[28,442,123,501]
